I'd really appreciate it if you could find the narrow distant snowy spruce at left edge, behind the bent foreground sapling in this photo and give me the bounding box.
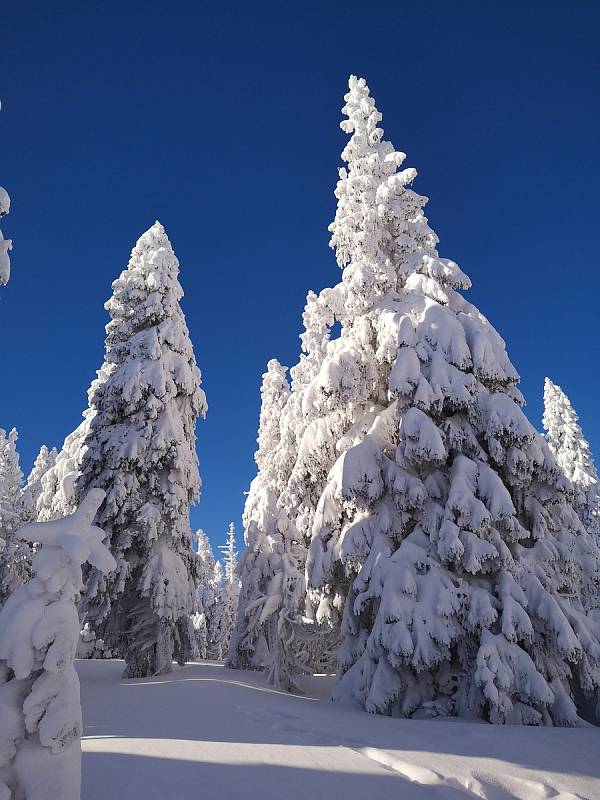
[0,428,31,606]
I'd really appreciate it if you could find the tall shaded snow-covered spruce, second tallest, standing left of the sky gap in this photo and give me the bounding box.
[76,222,206,677]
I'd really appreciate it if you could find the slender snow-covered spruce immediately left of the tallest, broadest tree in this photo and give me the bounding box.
[227,356,336,689]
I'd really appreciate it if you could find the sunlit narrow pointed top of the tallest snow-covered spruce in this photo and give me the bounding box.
[329,75,470,312]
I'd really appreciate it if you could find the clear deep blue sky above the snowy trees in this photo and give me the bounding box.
[0,0,600,545]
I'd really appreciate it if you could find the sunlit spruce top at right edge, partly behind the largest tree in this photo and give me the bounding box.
[542,378,600,541]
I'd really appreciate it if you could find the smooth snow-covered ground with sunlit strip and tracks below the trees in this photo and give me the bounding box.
[77,661,600,800]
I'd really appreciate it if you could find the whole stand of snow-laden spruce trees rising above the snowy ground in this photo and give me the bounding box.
[0,76,600,764]
